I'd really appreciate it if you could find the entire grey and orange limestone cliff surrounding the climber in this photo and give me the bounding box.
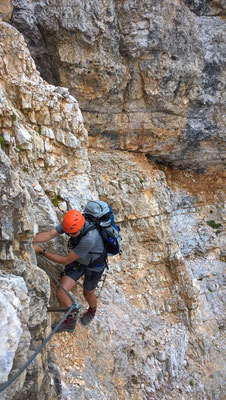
[0,1,225,400]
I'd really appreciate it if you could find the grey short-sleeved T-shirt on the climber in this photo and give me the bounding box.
[56,221,104,265]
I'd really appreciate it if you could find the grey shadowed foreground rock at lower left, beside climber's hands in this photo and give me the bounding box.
[0,150,50,400]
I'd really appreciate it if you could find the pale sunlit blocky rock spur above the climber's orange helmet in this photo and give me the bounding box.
[0,24,94,212]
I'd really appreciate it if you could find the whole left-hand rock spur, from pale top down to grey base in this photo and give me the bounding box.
[0,22,95,400]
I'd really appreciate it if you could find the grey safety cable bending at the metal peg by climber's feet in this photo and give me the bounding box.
[0,256,80,393]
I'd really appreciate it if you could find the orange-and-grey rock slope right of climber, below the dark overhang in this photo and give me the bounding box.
[48,150,225,400]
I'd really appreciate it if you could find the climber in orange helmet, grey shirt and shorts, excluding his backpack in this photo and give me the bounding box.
[33,210,106,332]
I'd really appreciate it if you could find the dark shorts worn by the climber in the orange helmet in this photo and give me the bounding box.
[65,262,105,290]
